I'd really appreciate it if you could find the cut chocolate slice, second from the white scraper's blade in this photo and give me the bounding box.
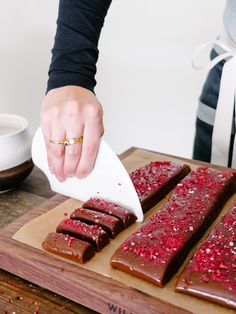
[70,208,124,238]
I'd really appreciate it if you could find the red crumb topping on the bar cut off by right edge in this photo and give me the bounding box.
[185,203,236,291]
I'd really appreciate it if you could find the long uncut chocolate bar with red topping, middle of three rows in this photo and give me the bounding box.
[111,168,235,287]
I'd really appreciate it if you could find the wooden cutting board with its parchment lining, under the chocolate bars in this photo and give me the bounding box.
[0,148,236,314]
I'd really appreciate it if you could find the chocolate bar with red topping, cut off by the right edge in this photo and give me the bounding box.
[175,203,236,310]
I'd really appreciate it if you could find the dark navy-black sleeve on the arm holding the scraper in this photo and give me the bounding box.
[47,0,112,92]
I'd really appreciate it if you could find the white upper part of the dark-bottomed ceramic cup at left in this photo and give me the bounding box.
[0,114,32,171]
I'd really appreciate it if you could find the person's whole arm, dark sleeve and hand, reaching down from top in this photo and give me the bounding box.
[41,0,111,181]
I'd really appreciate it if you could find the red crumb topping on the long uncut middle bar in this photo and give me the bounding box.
[122,167,233,268]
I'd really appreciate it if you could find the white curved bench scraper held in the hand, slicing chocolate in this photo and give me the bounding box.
[32,128,143,221]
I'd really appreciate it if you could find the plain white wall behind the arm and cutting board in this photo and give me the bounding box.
[0,0,225,157]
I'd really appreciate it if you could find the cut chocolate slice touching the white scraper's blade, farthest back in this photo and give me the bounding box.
[83,197,137,228]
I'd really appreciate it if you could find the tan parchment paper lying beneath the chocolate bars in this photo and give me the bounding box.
[13,149,236,314]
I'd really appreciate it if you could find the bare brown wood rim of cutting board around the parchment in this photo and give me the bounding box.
[0,148,233,314]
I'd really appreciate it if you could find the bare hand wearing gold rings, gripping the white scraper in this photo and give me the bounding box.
[41,86,104,181]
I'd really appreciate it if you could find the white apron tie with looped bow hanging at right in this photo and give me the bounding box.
[192,40,236,167]
